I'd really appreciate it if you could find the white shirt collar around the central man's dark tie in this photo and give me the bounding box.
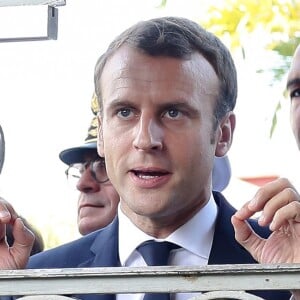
[118,195,218,266]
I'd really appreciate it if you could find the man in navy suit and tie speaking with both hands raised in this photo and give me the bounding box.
[0,17,300,300]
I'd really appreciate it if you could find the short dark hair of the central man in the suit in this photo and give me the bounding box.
[94,17,237,122]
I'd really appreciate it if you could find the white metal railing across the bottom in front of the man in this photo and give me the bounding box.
[0,264,300,299]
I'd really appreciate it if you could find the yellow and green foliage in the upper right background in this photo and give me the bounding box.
[161,0,300,136]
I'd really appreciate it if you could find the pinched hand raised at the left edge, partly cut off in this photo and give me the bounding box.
[0,198,34,270]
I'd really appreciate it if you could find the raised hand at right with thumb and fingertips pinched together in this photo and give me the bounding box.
[231,178,300,263]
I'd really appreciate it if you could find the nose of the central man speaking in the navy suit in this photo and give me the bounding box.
[133,117,163,151]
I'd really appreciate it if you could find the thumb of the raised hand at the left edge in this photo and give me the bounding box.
[10,218,35,269]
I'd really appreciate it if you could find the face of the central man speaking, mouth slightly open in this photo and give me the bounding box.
[98,46,231,234]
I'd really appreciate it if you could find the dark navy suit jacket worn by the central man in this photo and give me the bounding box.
[23,192,290,300]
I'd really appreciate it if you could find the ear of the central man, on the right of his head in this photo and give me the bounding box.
[215,111,235,156]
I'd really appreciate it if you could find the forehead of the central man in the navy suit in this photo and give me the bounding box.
[101,45,219,102]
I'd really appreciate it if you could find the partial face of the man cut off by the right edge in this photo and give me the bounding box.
[287,46,300,149]
